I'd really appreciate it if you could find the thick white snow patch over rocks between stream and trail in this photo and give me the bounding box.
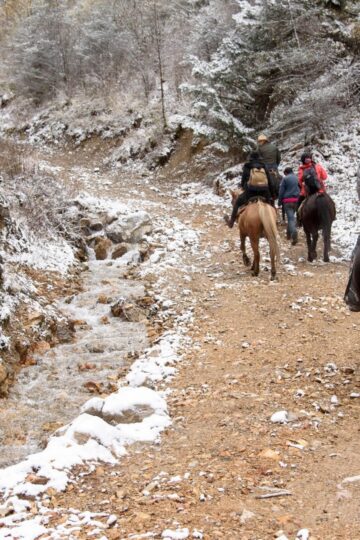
[0,401,170,496]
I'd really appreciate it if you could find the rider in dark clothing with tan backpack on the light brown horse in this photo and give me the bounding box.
[224,152,276,229]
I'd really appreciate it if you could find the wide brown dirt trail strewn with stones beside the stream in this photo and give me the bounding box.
[35,165,360,540]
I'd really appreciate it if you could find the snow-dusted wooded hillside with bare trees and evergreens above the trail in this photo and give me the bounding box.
[0,0,360,156]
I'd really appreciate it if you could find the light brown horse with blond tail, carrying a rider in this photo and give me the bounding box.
[231,191,280,280]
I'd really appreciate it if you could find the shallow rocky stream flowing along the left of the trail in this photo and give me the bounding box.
[0,259,147,467]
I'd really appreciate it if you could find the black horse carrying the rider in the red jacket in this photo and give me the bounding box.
[300,193,336,262]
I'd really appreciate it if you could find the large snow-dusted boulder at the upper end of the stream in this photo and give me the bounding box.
[106,212,152,244]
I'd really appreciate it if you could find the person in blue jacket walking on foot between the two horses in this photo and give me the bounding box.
[278,167,300,246]
